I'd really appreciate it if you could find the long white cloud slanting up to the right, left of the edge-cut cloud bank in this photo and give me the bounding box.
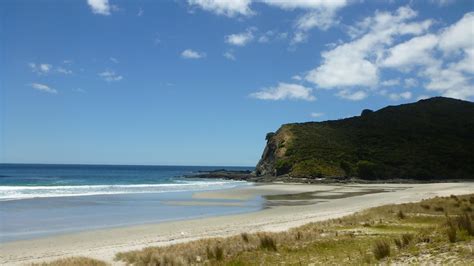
[306,7,432,88]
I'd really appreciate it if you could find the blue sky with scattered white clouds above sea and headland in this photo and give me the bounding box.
[0,0,474,166]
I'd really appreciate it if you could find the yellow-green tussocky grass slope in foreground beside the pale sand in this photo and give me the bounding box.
[116,195,474,265]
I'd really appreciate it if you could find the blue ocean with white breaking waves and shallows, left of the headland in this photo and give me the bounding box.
[0,164,262,242]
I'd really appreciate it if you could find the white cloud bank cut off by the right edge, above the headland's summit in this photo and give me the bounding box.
[382,12,474,99]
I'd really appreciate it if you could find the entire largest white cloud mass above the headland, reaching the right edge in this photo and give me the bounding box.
[304,7,474,100]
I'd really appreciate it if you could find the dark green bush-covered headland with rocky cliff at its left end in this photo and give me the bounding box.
[256,97,474,179]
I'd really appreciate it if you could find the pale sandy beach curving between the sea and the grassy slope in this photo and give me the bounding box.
[0,183,474,265]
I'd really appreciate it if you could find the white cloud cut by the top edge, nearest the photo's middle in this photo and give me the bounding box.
[188,0,254,17]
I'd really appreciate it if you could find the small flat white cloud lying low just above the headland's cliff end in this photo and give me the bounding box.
[250,82,316,101]
